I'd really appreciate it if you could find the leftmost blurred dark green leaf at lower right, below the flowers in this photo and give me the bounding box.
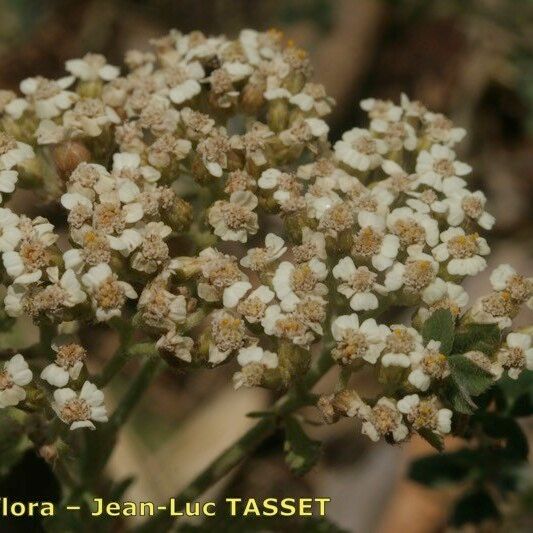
[408,448,480,487]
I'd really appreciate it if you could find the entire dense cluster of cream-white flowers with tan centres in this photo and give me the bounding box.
[0,30,533,454]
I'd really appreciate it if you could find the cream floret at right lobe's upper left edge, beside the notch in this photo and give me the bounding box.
[334,128,387,172]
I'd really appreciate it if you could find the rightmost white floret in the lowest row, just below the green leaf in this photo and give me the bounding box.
[397,394,453,435]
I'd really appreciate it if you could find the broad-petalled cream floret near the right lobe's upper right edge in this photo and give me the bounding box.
[416,144,472,190]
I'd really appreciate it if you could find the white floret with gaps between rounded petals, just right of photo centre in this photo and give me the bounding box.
[333,257,388,311]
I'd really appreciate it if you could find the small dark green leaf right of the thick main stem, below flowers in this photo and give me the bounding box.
[285,417,321,476]
